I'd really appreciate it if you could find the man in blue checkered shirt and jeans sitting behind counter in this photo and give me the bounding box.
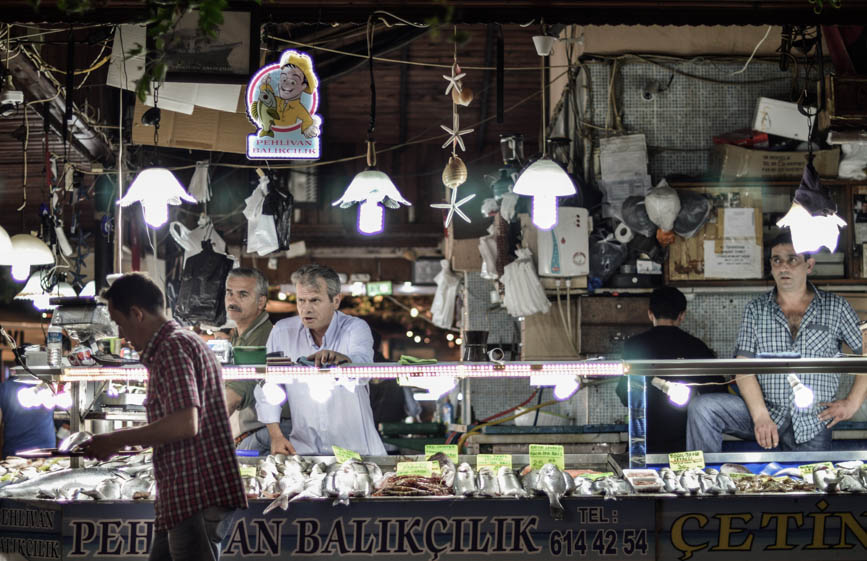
[686,230,867,452]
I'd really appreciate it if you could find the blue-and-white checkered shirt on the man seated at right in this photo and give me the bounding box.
[735,283,861,443]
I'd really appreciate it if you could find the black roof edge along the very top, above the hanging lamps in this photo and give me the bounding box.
[0,0,867,25]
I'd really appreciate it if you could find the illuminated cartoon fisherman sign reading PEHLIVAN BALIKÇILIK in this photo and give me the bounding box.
[247,50,322,159]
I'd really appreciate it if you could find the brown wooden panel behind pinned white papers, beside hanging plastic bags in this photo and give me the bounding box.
[665,186,762,282]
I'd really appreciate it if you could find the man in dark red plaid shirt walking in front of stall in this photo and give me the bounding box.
[86,273,247,561]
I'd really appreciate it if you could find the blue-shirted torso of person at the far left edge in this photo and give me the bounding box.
[0,377,57,458]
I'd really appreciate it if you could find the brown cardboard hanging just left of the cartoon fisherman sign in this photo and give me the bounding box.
[132,89,256,154]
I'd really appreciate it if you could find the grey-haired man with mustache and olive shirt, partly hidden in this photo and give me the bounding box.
[225,268,292,454]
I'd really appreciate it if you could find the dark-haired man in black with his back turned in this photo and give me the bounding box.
[616,286,724,454]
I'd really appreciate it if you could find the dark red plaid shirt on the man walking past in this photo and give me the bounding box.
[142,321,247,530]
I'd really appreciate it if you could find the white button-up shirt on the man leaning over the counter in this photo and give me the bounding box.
[255,312,386,456]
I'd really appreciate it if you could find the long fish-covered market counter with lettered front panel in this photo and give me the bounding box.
[0,454,867,561]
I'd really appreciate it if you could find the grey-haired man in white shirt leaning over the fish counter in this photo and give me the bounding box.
[256,264,386,456]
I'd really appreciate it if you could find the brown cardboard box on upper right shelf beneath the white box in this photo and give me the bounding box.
[709,144,840,179]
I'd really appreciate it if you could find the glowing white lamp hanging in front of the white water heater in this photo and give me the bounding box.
[512,157,576,230]
